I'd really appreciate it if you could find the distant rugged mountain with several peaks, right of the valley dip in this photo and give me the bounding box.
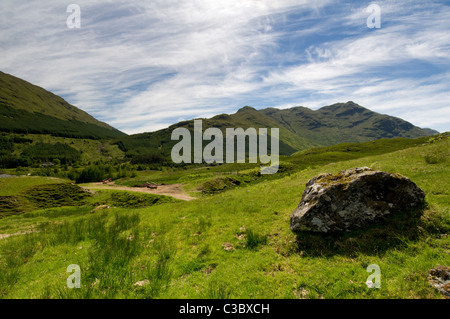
[117,101,439,156]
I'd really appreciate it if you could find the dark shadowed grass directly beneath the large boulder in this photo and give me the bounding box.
[296,205,426,257]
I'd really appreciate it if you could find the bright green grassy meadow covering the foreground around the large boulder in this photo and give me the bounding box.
[0,137,450,299]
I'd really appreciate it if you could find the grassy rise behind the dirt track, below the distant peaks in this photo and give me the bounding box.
[115,134,440,196]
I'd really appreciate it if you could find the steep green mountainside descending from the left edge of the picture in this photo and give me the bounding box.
[0,72,126,139]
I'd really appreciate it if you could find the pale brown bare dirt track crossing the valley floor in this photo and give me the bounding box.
[83,182,195,201]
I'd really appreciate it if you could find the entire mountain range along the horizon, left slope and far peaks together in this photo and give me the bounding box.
[0,72,438,156]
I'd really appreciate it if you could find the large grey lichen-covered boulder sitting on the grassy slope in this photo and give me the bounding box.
[290,167,425,233]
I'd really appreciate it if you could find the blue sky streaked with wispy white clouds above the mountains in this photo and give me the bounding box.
[0,0,450,134]
